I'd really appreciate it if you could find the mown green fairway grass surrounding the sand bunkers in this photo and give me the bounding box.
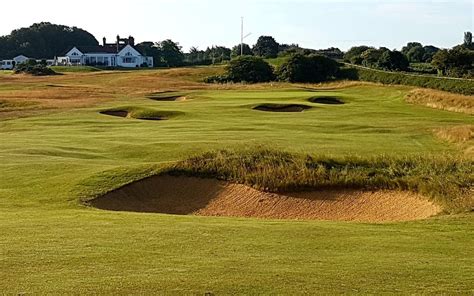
[0,78,474,294]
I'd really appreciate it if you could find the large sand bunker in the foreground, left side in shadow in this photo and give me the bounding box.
[90,176,441,222]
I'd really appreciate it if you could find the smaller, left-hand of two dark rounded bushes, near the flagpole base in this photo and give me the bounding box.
[227,56,274,83]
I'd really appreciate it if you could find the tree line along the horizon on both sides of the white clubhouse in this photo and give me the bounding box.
[0,22,474,78]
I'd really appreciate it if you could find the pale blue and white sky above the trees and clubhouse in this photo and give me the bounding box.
[0,0,474,50]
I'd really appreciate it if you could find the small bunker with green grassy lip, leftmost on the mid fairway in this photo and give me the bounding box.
[100,107,183,120]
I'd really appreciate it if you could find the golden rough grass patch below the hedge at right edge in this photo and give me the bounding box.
[406,89,474,114]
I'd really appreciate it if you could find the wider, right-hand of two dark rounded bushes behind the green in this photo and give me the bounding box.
[277,53,339,82]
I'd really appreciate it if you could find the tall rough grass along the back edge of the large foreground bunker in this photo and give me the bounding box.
[167,150,474,212]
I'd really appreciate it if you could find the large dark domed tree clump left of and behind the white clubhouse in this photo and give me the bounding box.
[0,22,99,59]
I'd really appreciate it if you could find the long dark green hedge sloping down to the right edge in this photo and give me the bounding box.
[341,66,474,95]
